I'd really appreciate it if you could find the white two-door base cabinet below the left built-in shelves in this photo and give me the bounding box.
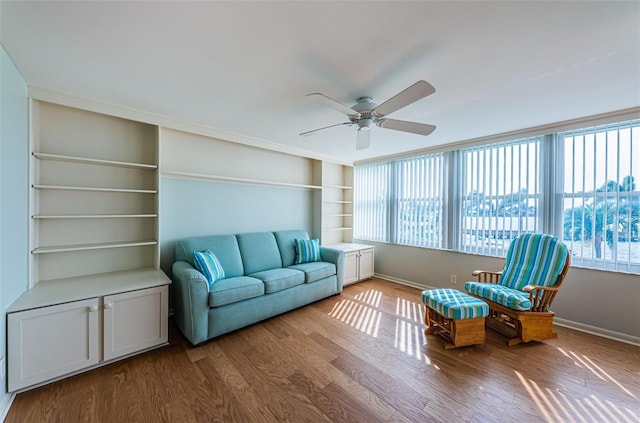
[7,270,168,391]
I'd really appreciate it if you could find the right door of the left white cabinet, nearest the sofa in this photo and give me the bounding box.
[104,286,168,360]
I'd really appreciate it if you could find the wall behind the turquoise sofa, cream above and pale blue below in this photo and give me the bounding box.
[160,128,317,275]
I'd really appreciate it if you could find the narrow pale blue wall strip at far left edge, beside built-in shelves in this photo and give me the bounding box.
[0,48,29,410]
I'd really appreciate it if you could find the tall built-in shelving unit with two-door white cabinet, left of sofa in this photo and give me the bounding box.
[7,101,170,391]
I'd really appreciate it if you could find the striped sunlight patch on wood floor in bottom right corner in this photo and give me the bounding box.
[514,370,640,423]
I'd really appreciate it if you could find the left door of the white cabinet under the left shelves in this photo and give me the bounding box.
[7,298,99,391]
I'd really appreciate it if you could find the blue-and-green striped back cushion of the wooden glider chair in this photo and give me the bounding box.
[500,234,568,291]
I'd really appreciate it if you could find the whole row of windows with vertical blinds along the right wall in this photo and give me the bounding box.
[354,120,640,273]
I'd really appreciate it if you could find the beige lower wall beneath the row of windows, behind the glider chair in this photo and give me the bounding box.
[359,241,640,344]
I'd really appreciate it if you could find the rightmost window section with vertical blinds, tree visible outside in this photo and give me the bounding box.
[558,120,640,271]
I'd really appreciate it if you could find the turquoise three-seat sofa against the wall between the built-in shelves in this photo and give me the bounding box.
[172,230,344,345]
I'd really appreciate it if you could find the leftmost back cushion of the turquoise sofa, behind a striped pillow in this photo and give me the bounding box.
[175,235,244,278]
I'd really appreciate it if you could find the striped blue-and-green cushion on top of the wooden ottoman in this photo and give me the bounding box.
[422,288,489,320]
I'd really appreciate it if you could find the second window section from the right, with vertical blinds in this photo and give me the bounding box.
[458,137,542,256]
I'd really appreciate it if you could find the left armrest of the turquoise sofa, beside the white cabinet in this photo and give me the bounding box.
[172,261,209,345]
